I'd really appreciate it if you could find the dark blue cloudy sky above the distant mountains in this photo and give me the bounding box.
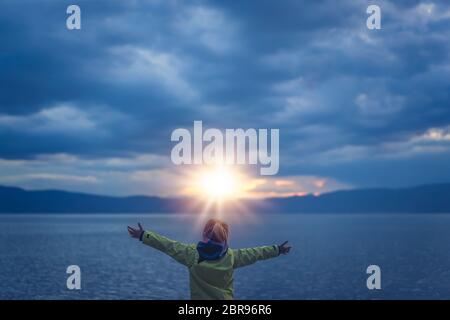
[0,0,450,195]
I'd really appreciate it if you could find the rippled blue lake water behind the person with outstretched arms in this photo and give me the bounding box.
[0,214,450,299]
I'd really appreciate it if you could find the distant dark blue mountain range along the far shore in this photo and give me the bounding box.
[0,183,450,213]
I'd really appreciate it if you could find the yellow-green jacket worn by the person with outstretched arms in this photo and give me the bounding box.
[142,231,279,300]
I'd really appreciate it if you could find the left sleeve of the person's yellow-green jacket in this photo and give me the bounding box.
[142,231,197,267]
